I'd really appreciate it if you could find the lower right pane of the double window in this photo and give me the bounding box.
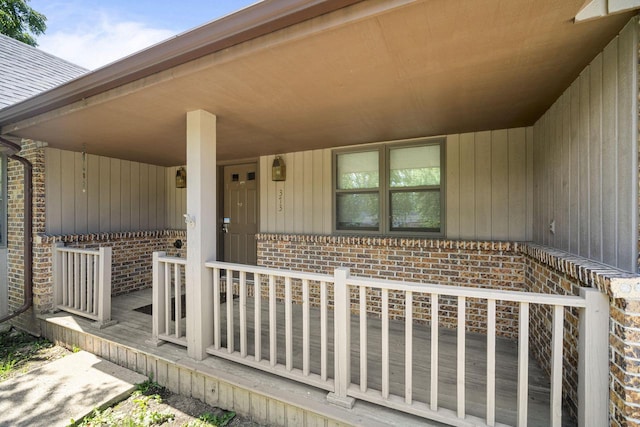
[391,190,440,231]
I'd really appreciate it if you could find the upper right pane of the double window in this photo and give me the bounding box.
[389,145,440,188]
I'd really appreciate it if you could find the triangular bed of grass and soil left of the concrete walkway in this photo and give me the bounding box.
[0,328,68,381]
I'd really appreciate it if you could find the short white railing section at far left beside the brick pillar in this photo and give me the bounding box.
[52,242,117,328]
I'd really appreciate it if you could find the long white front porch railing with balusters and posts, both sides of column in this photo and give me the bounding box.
[154,254,608,426]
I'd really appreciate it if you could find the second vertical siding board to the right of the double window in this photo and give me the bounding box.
[460,133,477,239]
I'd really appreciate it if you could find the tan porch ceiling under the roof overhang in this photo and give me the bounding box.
[0,0,633,166]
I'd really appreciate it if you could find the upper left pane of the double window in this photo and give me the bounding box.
[337,151,380,190]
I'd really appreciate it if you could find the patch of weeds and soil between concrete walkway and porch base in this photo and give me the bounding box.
[70,377,236,427]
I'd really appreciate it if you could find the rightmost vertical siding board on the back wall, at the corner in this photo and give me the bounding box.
[507,128,527,241]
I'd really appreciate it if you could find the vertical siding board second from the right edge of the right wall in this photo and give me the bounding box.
[602,39,618,265]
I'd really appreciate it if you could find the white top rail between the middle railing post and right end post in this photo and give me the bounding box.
[347,277,586,307]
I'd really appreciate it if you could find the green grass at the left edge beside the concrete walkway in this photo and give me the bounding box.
[0,328,53,381]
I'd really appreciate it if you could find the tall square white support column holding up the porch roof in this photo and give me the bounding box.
[185,110,217,360]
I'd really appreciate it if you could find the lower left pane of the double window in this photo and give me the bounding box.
[336,193,380,230]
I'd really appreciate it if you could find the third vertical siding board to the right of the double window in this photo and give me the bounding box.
[475,131,491,240]
